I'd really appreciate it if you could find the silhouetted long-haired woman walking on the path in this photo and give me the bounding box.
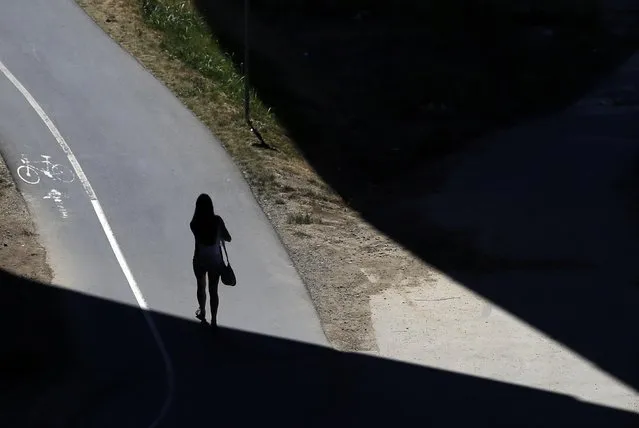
[190,193,231,328]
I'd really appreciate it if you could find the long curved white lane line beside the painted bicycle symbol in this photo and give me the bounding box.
[0,61,174,428]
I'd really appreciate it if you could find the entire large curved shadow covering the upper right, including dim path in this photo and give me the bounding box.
[190,0,639,389]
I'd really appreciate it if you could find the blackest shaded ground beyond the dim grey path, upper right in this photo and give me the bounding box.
[195,0,636,189]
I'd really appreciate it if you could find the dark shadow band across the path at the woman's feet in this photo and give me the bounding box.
[0,271,637,427]
